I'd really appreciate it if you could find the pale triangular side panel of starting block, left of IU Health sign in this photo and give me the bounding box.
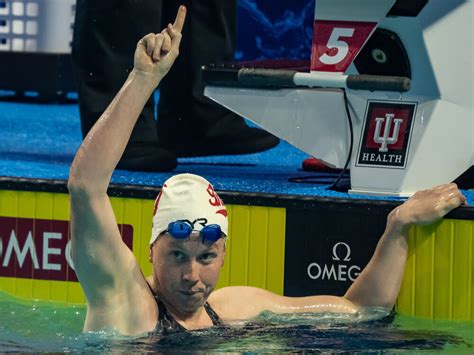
[205,86,349,167]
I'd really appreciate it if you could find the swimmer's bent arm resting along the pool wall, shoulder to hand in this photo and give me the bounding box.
[213,184,466,319]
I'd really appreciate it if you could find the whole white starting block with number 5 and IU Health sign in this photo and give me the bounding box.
[203,0,474,197]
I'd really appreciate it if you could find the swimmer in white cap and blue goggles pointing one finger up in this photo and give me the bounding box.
[68,7,465,335]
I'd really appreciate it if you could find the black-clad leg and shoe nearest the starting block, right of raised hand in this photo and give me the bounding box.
[158,0,279,156]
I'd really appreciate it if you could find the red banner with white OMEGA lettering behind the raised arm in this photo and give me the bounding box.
[0,217,133,281]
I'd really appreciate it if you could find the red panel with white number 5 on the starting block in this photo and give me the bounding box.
[311,20,377,73]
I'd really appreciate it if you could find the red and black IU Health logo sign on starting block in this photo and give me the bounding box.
[356,101,416,169]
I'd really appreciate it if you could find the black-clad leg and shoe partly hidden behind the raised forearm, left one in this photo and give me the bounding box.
[72,0,176,171]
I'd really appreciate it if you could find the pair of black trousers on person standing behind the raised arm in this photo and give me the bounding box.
[72,0,245,148]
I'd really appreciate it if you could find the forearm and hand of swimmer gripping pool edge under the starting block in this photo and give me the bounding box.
[344,184,466,308]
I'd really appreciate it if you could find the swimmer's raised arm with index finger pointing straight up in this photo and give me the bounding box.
[68,7,186,305]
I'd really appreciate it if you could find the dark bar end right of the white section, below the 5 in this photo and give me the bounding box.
[346,75,411,92]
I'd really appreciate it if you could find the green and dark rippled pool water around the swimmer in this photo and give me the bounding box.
[0,292,474,354]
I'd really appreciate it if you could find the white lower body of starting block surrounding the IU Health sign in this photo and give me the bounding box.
[205,86,474,197]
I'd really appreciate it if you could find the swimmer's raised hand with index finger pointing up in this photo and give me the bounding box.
[134,6,186,80]
